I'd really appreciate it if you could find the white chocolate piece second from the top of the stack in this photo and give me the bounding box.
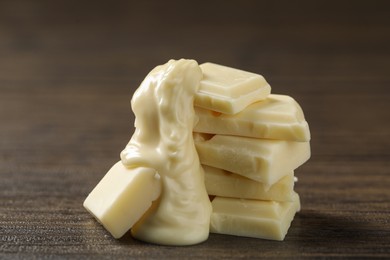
[194,94,310,142]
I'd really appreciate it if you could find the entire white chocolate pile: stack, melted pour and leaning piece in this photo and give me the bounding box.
[84,59,310,245]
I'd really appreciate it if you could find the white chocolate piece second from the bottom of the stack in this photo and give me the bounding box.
[203,165,295,201]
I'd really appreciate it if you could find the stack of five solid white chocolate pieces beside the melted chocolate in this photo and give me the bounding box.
[194,63,310,240]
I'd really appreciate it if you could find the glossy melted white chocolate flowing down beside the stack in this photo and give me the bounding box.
[121,59,212,245]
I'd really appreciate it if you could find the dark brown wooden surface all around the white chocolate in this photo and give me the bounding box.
[0,0,390,259]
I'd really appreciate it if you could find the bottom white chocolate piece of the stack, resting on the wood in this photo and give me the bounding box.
[210,193,300,241]
